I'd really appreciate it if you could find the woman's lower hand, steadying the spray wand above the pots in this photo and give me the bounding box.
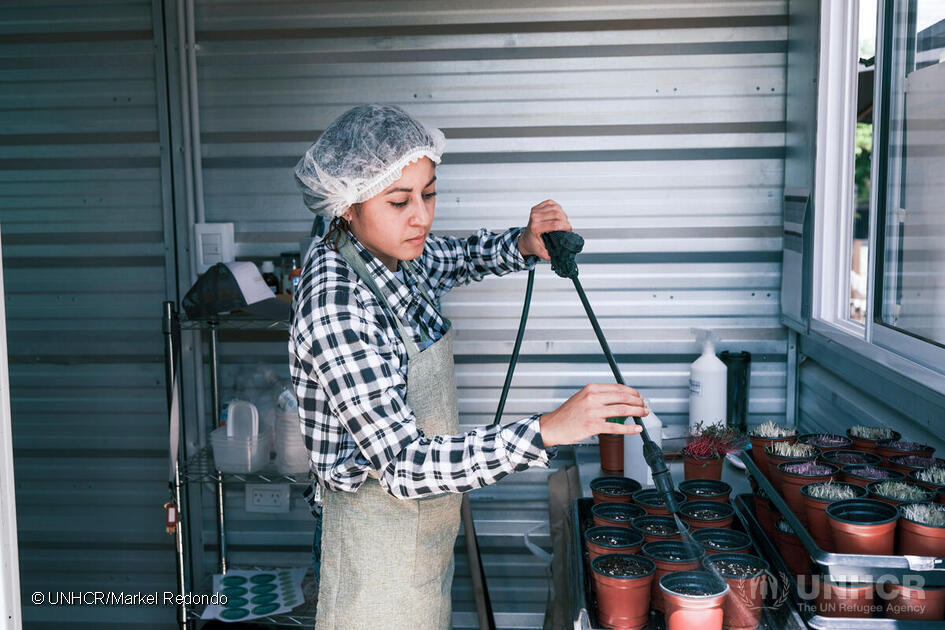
[538,383,650,448]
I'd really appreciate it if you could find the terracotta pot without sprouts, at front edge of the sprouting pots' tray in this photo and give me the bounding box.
[827,499,899,555]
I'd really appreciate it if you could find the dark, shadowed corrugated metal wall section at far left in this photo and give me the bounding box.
[0,1,174,629]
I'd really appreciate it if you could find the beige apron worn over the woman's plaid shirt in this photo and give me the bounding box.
[315,238,462,630]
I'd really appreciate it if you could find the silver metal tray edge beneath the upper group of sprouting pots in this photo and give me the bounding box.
[740,451,945,588]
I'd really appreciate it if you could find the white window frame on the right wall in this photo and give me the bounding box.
[810,0,945,394]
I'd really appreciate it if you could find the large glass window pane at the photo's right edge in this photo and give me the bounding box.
[875,0,945,347]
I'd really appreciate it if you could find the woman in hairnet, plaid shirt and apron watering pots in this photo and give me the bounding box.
[289,105,647,630]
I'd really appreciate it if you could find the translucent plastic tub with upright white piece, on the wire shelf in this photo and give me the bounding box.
[210,400,272,473]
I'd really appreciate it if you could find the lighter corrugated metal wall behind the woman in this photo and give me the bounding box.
[186,0,787,627]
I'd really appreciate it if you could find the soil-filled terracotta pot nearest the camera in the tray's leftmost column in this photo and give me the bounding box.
[591,554,656,630]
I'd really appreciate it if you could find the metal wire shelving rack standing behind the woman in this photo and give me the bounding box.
[162,302,315,630]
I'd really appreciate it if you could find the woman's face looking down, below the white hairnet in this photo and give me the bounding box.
[344,158,436,271]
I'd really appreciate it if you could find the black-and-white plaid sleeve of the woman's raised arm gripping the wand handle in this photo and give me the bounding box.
[420,227,540,297]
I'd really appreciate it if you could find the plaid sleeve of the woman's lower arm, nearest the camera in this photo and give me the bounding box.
[295,287,549,498]
